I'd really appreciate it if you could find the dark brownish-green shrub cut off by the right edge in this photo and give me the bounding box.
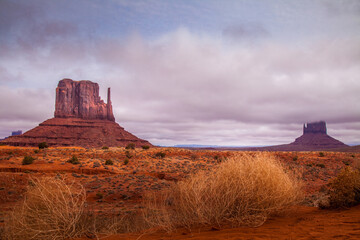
[329,167,360,208]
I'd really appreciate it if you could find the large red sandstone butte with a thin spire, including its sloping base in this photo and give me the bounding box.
[1,79,152,147]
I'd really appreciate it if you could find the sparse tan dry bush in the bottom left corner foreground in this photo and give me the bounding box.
[4,177,86,239]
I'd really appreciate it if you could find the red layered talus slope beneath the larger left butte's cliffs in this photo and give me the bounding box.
[4,118,151,147]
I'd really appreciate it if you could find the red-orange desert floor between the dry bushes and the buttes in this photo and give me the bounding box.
[0,146,360,239]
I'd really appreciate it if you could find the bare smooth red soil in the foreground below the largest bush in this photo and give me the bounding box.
[100,206,360,240]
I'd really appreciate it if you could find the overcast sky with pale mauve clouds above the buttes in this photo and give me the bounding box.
[0,0,360,146]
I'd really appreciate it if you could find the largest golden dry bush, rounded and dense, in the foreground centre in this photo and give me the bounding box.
[144,153,302,231]
